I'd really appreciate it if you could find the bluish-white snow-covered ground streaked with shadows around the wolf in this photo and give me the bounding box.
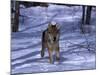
[11,5,96,74]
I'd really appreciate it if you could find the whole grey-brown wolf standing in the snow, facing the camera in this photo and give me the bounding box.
[41,23,60,63]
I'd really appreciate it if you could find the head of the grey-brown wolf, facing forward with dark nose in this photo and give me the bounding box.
[48,23,59,43]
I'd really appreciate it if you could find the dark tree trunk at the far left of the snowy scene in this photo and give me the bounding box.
[12,1,19,32]
